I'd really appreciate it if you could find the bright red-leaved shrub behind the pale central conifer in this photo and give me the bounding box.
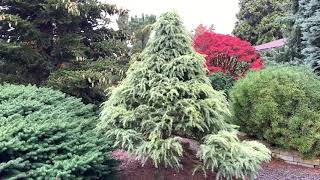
[193,30,263,79]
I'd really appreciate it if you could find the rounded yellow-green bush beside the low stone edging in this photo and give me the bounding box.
[231,67,320,157]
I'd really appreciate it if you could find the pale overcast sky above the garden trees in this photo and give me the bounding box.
[100,0,239,34]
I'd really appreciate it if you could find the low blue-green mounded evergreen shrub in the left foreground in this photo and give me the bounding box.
[0,84,116,179]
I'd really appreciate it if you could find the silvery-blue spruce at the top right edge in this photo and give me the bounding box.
[301,0,320,75]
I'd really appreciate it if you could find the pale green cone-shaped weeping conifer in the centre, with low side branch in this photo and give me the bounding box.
[98,12,270,179]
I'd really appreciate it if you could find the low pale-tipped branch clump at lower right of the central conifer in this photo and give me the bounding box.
[197,131,270,180]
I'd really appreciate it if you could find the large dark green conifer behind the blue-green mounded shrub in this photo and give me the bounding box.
[0,0,128,102]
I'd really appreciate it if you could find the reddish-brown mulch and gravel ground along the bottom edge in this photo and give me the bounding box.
[113,150,320,180]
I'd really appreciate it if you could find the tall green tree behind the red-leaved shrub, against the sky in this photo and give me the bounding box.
[233,0,287,45]
